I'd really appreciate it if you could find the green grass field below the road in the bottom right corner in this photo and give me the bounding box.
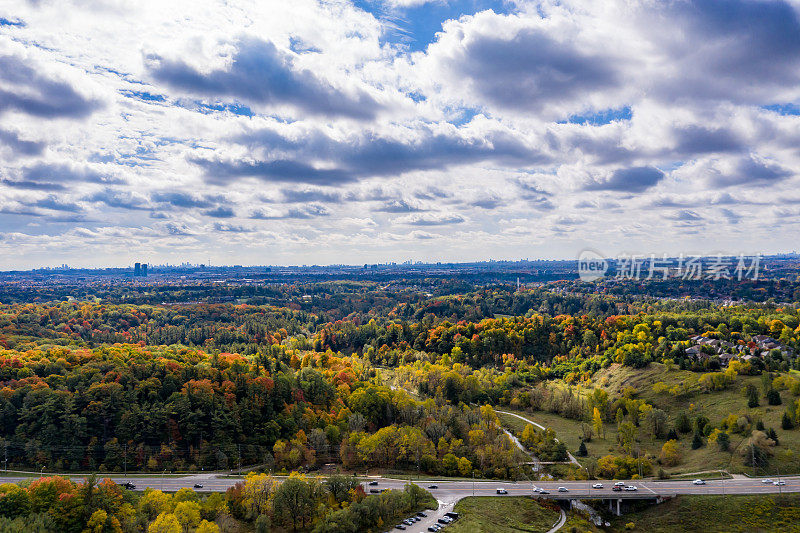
[611,494,800,533]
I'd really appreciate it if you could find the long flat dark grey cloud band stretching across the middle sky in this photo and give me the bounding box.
[195,130,549,185]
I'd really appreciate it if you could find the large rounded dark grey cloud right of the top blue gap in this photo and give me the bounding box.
[454,28,617,110]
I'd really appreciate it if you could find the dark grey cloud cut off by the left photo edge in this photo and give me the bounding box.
[0,55,101,118]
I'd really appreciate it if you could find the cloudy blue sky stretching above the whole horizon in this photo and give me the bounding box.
[0,0,800,270]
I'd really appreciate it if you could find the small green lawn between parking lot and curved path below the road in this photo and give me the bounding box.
[447,496,560,533]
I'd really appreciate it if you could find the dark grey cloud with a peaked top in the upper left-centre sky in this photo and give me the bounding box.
[147,38,380,120]
